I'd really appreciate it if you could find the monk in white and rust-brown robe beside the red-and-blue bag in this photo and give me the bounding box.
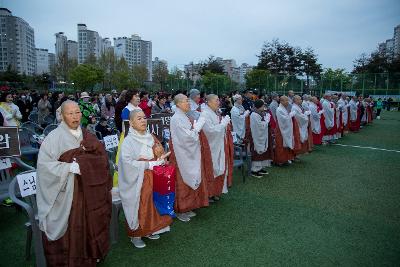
[118,110,172,248]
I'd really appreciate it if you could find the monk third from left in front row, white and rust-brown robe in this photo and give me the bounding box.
[170,94,212,222]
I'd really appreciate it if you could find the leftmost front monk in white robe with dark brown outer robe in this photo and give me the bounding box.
[36,100,112,266]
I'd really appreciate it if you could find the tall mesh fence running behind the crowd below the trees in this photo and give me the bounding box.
[0,73,400,98]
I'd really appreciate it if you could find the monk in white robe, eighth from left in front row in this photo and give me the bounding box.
[292,95,311,154]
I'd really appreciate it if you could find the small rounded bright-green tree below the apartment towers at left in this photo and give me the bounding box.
[71,64,103,91]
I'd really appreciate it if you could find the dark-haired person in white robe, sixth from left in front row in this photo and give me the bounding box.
[250,99,271,178]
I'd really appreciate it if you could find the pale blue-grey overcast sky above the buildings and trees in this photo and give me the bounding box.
[0,0,400,71]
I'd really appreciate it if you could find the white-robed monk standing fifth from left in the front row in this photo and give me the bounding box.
[231,95,250,142]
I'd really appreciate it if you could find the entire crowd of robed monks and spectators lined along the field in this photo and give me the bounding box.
[0,89,380,266]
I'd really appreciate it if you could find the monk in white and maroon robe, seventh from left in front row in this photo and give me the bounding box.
[274,96,295,165]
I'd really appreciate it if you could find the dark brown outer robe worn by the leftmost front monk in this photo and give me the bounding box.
[43,129,112,266]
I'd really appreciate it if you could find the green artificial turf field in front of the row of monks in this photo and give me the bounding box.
[0,112,400,266]
